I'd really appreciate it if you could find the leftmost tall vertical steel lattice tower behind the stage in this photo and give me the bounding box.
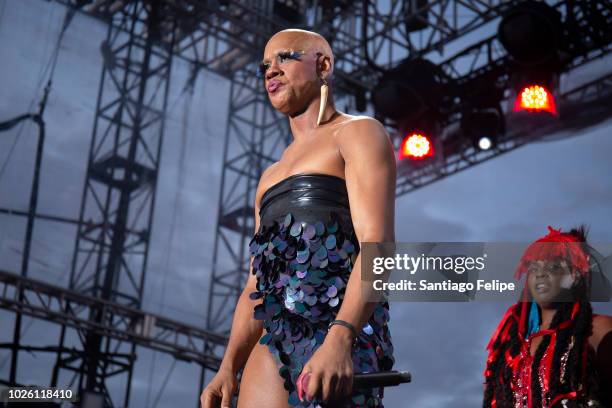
[51,2,173,406]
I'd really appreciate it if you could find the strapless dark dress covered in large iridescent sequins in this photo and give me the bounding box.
[249,173,394,408]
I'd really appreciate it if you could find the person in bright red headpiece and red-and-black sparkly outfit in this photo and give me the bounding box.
[483,226,612,408]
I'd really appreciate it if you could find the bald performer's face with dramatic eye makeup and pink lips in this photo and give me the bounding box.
[260,33,319,115]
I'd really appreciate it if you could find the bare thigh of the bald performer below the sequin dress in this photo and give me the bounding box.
[238,343,289,408]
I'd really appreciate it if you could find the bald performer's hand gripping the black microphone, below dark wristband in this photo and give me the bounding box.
[298,326,353,402]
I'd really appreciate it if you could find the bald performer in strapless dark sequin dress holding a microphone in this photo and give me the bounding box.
[200,29,396,408]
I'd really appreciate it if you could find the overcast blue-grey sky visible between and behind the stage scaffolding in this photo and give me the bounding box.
[0,0,612,408]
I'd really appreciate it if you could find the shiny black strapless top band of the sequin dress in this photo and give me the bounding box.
[259,173,352,228]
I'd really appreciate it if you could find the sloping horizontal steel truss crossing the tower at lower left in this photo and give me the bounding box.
[0,270,227,370]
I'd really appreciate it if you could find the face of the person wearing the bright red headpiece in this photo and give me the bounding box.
[527,260,573,307]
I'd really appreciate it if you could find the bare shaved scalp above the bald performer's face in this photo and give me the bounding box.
[264,28,334,80]
